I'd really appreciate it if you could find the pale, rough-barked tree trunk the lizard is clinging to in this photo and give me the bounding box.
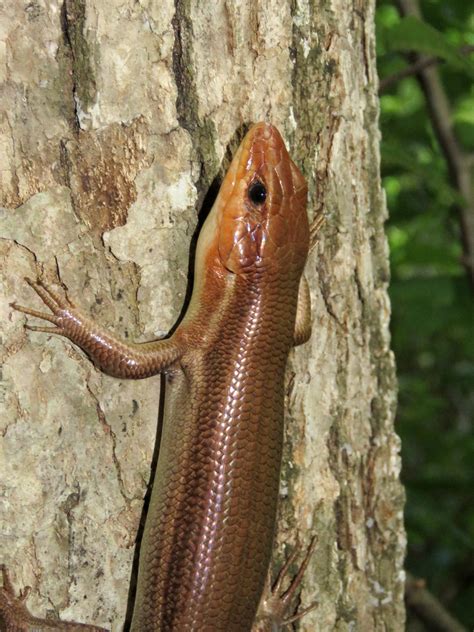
[0,0,405,632]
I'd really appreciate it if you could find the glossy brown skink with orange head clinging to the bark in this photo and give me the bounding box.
[0,123,320,632]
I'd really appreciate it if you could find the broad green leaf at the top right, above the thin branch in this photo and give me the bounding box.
[382,15,474,77]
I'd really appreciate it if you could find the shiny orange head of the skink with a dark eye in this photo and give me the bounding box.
[198,123,309,282]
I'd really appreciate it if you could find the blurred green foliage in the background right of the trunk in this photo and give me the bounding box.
[376,0,474,628]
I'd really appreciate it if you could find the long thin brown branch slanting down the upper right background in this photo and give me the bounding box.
[397,0,474,288]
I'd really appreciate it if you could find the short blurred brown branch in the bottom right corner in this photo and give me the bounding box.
[405,573,467,632]
